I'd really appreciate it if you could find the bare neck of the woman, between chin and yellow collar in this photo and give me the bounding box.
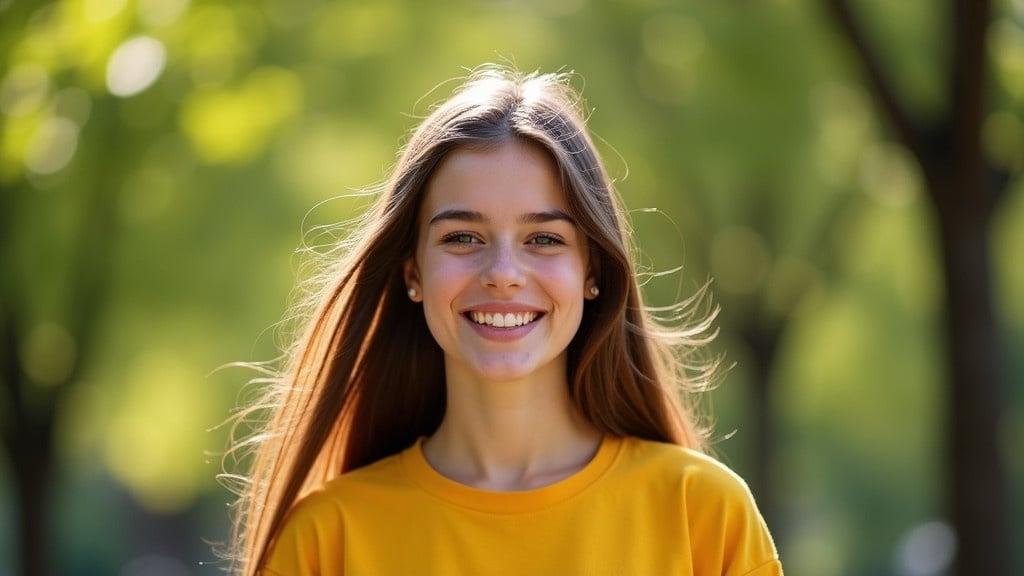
[423,355,603,490]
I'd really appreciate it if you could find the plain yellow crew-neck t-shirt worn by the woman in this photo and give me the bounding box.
[264,436,782,576]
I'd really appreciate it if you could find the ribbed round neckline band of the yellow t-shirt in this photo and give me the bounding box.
[398,434,623,513]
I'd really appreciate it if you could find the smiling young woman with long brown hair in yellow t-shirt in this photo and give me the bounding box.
[226,66,782,576]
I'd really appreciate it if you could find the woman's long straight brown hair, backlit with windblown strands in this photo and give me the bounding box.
[222,65,719,576]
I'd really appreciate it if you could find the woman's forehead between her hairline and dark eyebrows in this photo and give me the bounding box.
[423,140,566,217]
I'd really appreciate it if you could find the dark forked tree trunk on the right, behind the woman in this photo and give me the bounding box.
[827,0,1013,565]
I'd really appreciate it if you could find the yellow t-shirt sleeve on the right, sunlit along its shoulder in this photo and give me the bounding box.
[686,457,782,576]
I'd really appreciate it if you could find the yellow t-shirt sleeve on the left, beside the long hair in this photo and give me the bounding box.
[261,493,344,576]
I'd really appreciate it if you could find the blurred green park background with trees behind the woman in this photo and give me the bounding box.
[0,0,1024,576]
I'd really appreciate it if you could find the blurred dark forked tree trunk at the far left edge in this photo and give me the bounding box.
[0,98,121,576]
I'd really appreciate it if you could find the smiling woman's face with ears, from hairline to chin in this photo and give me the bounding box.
[404,140,594,380]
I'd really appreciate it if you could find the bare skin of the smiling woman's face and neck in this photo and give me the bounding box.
[404,140,601,491]
